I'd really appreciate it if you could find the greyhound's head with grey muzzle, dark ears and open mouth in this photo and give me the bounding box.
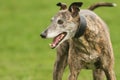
[40,2,83,48]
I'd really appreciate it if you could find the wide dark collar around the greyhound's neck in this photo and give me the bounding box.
[74,15,87,38]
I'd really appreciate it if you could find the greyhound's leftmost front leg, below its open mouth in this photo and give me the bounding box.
[53,41,69,80]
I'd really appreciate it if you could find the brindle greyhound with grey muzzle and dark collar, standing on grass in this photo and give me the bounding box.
[40,2,116,80]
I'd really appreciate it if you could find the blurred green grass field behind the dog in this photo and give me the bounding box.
[0,0,120,80]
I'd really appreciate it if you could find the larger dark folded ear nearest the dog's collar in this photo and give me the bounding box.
[68,2,83,17]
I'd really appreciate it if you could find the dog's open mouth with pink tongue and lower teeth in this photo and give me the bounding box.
[50,32,67,49]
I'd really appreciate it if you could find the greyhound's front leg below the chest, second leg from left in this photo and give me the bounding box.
[68,49,83,80]
